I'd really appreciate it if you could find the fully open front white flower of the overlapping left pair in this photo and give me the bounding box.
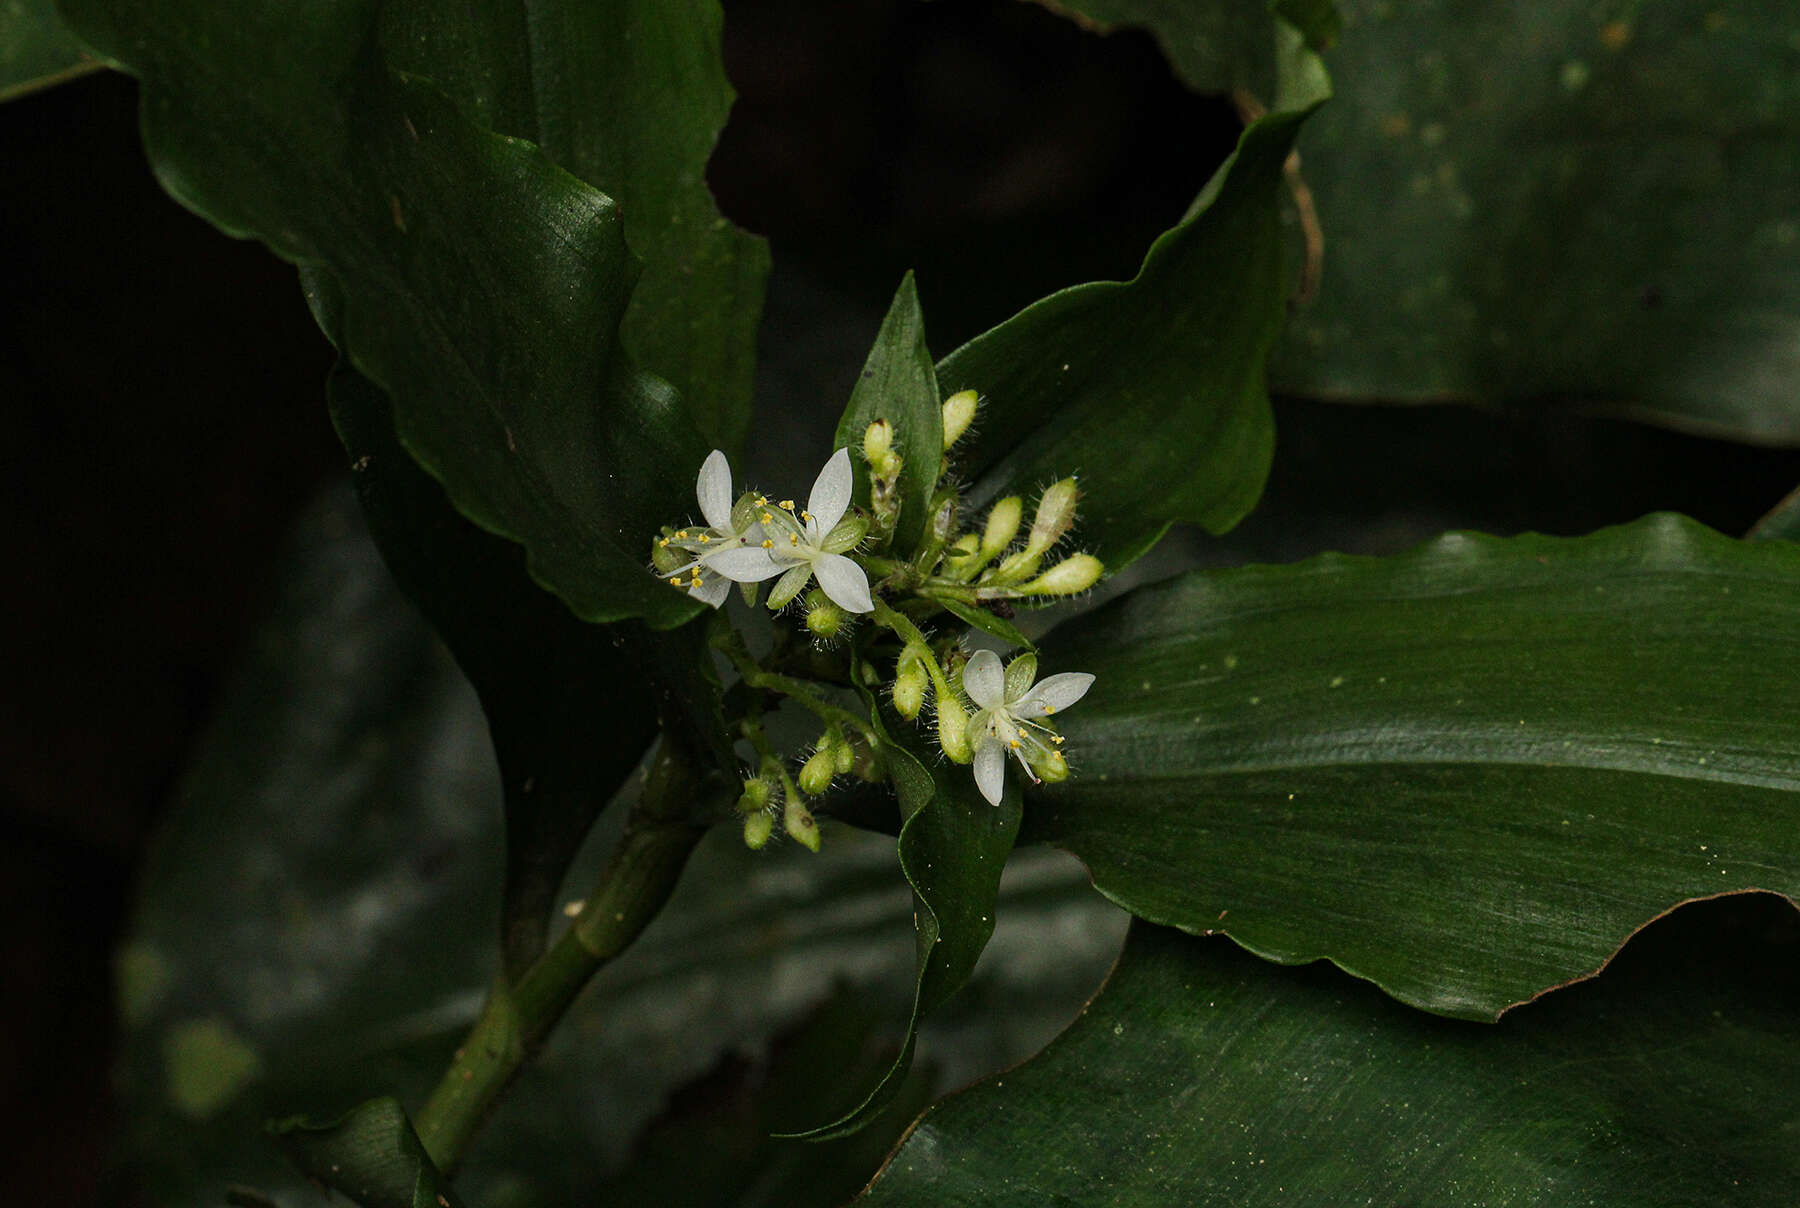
[706,448,875,612]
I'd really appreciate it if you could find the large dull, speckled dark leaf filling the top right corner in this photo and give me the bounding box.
[1271,0,1800,445]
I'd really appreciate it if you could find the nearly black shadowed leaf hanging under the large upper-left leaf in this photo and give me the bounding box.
[329,365,712,974]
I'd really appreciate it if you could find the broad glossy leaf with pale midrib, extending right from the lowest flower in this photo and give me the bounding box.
[1028,515,1800,1019]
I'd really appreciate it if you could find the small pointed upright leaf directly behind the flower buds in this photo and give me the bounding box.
[835,272,943,549]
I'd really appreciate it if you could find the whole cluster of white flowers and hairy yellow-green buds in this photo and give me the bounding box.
[652,391,1105,850]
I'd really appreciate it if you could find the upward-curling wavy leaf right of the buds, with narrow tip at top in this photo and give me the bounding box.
[938,23,1325,571]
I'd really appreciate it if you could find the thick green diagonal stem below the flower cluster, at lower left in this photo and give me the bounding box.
[412,740,707,1174]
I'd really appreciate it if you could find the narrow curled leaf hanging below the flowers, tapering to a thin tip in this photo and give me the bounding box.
[794,669,1021,1141]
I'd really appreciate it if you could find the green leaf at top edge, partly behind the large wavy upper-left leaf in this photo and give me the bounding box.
[380,0,769,451]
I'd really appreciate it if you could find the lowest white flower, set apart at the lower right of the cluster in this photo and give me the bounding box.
[963,650,1094,805]
